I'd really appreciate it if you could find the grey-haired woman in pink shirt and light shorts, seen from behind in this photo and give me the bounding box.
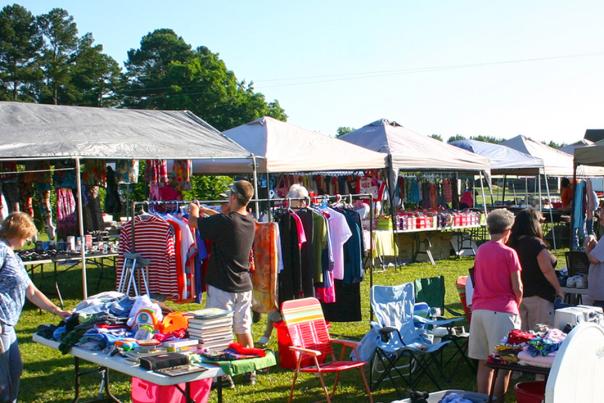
[468,209,522,402]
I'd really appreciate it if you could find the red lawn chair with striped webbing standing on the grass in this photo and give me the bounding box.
[281,298,373,403]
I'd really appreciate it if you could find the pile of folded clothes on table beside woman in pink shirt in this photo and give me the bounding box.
[489,326,566,368]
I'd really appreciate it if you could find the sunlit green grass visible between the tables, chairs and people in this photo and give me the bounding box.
[17,251,568,403]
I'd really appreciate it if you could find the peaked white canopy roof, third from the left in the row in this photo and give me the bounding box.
[341,119,489,171]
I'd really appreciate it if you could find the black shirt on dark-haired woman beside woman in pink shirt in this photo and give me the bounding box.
[514,237,556,302]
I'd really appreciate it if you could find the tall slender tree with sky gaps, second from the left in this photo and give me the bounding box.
[38,8,78,105]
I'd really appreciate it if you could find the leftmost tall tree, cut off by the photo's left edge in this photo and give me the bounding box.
[0,4,43,101]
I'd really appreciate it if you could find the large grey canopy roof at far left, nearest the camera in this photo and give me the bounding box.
[0,102,249,164]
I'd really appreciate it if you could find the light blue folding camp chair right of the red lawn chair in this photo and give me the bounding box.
[359,283,449,393]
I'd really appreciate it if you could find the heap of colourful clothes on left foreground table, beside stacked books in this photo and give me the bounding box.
[37,291,266,363]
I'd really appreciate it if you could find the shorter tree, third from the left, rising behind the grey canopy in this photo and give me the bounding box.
[70,33,121,107]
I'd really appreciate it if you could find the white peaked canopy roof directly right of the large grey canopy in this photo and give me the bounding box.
[194,116,386,173]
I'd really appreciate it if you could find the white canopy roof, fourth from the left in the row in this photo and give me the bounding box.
[450,140,543,175]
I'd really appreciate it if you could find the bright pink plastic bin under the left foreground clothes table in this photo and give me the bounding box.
[130,378,212,403]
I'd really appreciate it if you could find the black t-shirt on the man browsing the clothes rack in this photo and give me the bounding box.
[198,212,256,292]
